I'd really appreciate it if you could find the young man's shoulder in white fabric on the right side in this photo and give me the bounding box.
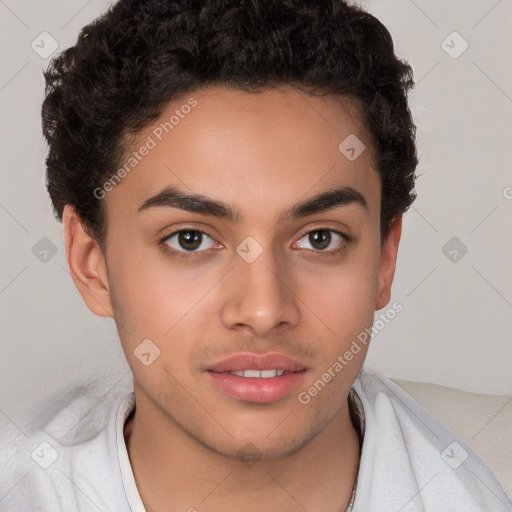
[353,369,512,512]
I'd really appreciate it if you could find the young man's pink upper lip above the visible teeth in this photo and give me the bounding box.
[208,352,306,373]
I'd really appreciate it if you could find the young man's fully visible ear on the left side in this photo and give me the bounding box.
[62,205,114,317]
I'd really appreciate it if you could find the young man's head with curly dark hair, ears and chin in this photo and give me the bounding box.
[43,0,417,457]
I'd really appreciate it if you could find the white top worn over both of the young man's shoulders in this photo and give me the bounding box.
[0,369,512,512]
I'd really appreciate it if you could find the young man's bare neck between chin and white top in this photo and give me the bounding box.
[124,390,360,512]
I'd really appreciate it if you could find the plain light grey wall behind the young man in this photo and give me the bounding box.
[0,0,512,423]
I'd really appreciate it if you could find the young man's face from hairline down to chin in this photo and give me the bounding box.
[66,87,400,457]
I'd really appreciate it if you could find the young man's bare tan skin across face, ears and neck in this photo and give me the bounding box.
[63,87,401,512]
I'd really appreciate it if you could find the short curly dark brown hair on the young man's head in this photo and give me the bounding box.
[42,0,418,247]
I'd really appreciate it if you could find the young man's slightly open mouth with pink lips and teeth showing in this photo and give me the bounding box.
[205,353,308,403]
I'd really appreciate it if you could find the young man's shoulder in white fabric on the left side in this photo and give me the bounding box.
[0,378,130,512]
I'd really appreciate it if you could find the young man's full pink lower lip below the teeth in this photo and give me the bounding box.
[206,370,306,403]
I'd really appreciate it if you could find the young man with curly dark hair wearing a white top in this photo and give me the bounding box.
[0,0,511,512]
